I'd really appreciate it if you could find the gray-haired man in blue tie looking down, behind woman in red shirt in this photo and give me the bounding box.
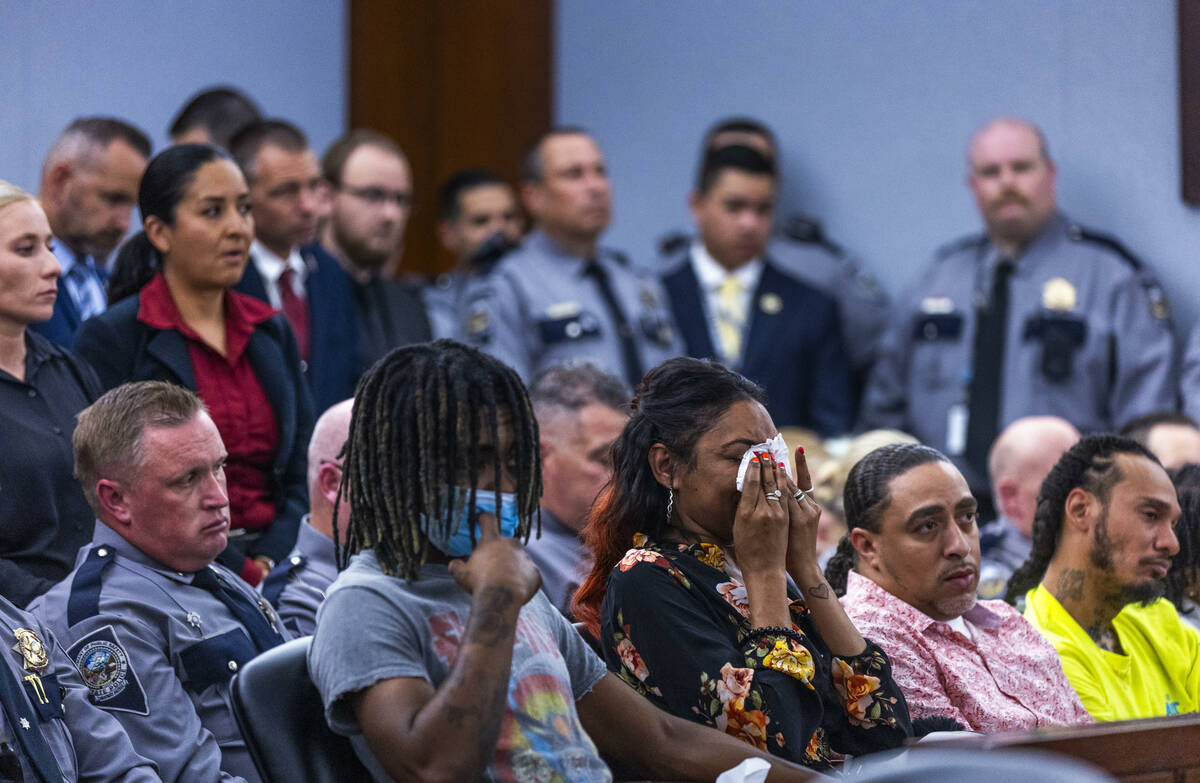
[31,116,150,348]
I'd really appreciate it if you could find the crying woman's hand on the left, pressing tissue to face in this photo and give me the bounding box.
[733,452,796,575]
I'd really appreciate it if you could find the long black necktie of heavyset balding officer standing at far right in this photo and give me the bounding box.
[964,258,1013,480]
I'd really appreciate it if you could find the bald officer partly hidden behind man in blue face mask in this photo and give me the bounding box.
[263,400,354,636]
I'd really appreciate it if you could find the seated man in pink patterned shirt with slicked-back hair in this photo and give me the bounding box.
[826,444,1092,731]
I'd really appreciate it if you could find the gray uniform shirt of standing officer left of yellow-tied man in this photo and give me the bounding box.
[464,232,683,385]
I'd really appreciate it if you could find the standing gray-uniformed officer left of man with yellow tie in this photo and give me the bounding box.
[464,128,683,387]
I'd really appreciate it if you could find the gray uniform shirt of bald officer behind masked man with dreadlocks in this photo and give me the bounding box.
[262,514,337,636]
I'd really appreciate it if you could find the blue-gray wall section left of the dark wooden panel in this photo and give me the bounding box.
[0,0,346,191]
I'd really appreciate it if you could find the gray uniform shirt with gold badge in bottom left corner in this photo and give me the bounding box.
[0,598,160,783]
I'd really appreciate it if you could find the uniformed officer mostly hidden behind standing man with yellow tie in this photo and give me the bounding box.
[659,116,888,389]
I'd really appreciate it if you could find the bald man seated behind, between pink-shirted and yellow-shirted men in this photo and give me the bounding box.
[979,416,1079,598]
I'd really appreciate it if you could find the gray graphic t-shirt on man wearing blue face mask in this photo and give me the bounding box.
[308,551,612,783]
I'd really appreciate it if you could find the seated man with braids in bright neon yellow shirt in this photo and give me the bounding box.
[1006,435,1200,721]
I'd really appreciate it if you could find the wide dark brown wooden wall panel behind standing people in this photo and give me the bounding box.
[348,0,552,274]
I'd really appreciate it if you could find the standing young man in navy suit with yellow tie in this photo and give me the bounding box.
[662,145,852,436]
